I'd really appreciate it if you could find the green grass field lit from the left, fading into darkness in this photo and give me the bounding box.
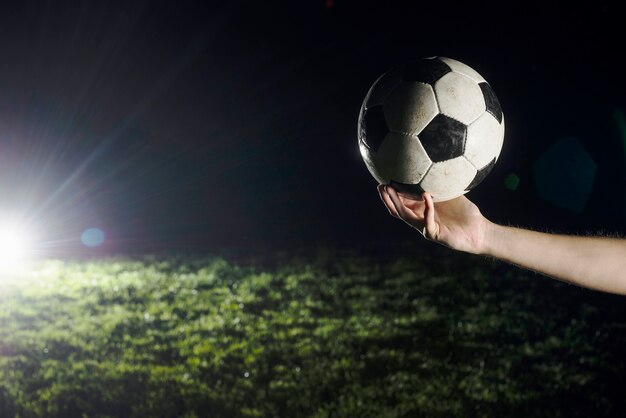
[0,246,626,418]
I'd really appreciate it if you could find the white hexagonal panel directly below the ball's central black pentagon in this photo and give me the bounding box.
[420,157,478,202]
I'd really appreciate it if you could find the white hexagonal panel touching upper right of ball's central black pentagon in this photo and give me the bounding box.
[435,72,486,125]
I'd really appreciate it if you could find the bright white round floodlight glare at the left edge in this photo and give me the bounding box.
[0,223,33,274]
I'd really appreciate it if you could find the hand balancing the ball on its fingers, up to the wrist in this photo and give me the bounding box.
[378,184,491,254]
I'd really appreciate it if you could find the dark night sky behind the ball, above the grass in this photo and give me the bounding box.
[0,0,626,254]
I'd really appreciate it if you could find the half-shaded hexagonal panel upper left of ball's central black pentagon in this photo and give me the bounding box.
[383,81,439,134]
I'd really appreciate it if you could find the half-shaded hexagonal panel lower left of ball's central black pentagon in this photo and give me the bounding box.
[371,132,431,183]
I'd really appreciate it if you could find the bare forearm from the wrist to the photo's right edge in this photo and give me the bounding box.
[481,223,626,294]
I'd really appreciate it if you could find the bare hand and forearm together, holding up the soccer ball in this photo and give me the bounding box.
[378,185,626,295]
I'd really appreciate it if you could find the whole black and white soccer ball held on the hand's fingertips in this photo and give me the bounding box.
[358,57,504,202]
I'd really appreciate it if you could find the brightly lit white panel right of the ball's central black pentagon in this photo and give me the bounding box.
[463,112,504,170]
